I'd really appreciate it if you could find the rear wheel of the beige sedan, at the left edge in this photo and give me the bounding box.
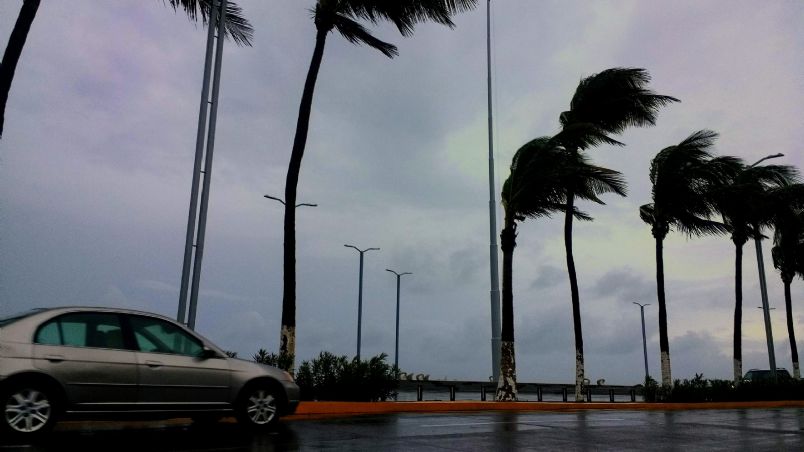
[0,383,59,437]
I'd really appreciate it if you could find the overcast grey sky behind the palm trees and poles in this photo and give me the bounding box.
[0,0,804,384]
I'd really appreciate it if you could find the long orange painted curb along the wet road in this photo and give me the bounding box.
[288,400,804,419]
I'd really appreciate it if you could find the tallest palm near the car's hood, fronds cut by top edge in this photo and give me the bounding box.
[279,0,477,370]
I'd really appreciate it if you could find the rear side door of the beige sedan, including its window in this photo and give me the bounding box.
[32,312,137,410]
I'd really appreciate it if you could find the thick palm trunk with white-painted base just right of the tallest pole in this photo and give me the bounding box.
[496,215,517,402]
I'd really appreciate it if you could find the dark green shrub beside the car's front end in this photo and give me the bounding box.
[296,352,398,402]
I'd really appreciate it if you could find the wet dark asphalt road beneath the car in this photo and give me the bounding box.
[0,408,804,452]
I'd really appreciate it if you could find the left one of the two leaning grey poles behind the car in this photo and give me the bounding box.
[176,0,218,323]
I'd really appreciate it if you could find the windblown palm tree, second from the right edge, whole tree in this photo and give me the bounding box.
[714,161,796,383]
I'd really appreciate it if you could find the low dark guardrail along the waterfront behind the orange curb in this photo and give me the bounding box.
[399,380,643,402]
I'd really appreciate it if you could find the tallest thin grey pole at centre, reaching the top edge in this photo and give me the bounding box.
[486,0,502,381]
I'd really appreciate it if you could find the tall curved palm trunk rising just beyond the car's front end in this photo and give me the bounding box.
[279,30,327,372]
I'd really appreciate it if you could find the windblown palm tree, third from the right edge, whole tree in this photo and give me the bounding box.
[639,130,738,386]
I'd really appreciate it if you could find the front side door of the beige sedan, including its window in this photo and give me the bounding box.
[128,315,230,409]
